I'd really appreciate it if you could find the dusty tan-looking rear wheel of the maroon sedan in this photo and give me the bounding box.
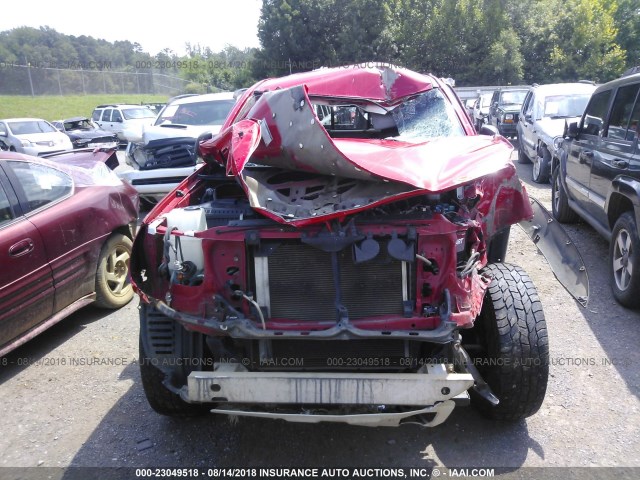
[96,233,133,308]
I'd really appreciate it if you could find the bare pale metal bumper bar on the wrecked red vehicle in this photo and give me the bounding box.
[181,364,474,426]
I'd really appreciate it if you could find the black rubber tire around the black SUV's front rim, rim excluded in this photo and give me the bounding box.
[609,212,640,308]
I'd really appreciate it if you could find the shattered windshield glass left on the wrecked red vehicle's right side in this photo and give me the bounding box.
[392,88,465,142]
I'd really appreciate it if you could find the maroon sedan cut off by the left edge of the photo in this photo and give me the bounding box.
[0,150,138,356]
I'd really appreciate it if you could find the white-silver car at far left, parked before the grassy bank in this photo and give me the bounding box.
[0,118,73,157]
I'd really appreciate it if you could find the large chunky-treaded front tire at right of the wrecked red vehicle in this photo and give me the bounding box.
[473,263,549,421]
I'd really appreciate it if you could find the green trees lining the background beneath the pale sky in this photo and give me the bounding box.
[0,0,640,93]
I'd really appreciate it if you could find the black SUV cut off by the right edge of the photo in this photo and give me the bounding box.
[552,74,640,308]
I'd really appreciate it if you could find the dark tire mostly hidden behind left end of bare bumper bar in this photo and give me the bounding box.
[139,339,211,417]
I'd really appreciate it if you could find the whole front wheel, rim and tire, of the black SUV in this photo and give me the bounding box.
[609,212,640,308]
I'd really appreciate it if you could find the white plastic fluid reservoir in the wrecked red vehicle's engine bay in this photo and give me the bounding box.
[166,207,207,270]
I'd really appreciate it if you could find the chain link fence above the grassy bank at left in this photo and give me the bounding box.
[0,62,189,96]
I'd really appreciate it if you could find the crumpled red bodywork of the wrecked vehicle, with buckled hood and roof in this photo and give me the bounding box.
[132,67,533,338]
